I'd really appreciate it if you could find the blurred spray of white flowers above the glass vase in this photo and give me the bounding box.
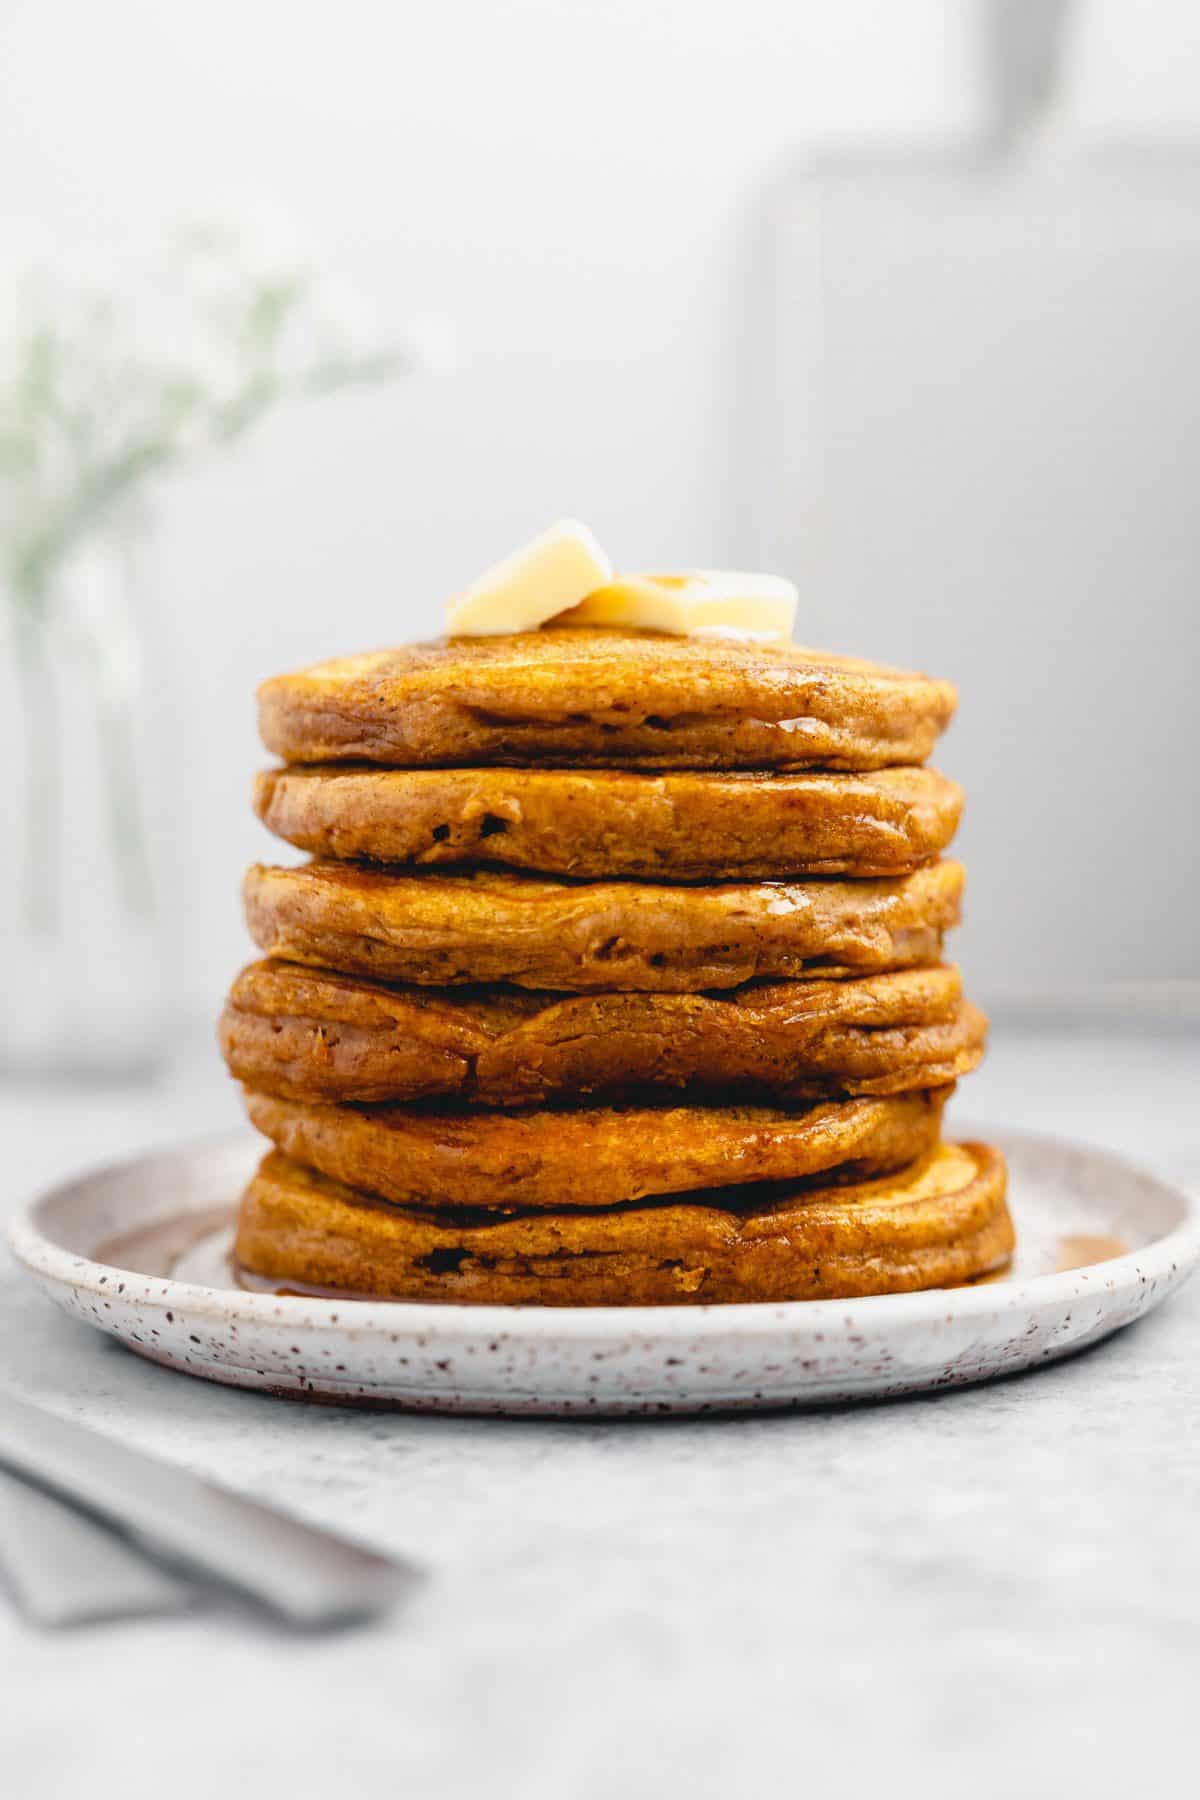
[0,198,446,585]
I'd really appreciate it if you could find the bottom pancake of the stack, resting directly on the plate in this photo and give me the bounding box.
[236,1143,1013,1307]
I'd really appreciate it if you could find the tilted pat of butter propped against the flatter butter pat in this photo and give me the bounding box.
[446,518,612,637]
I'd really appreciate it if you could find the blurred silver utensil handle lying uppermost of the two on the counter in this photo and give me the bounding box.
[0,1393,417,1625]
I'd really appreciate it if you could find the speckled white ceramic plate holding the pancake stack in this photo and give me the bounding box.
[11,1132,1200,1413]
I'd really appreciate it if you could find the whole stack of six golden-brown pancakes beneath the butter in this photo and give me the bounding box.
[221,626,1013,1305]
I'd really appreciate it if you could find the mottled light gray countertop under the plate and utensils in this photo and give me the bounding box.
[0,1028,1200,1800]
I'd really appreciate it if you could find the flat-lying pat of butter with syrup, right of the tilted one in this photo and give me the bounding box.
[560,569,797,639]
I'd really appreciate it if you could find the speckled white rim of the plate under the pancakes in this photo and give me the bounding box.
[5,1121,1200,1339]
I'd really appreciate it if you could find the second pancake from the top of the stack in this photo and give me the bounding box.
[254,767,963,882]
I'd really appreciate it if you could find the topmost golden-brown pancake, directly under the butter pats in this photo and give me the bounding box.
[259,626,955,769]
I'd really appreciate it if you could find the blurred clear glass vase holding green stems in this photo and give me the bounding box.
[0,529,166,1078]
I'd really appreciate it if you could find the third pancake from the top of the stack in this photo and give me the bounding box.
[243,862,963,994]
